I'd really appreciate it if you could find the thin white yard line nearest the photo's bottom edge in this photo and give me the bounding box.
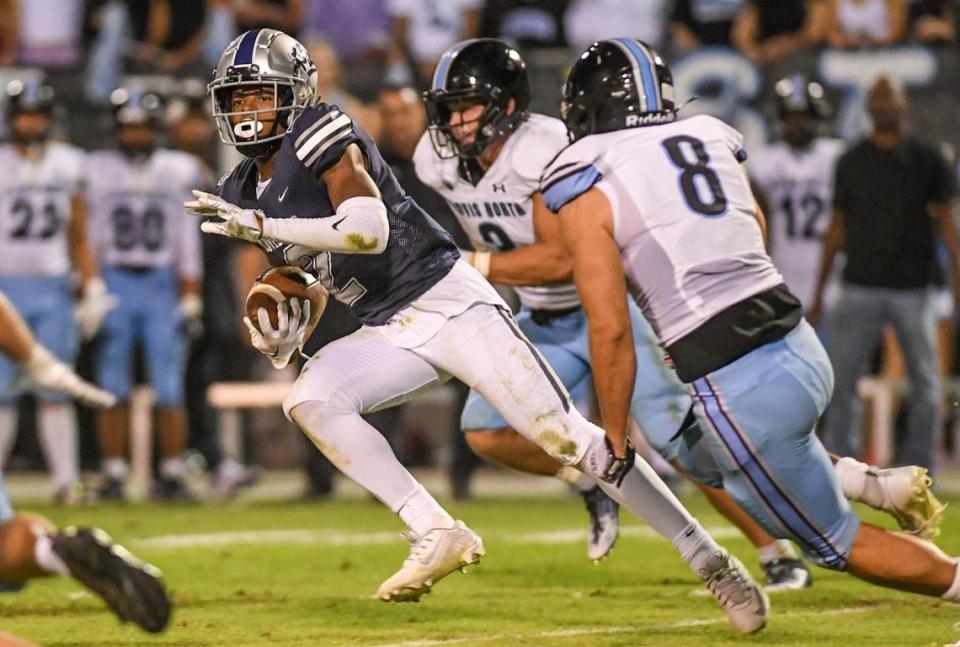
[374,604,890,647]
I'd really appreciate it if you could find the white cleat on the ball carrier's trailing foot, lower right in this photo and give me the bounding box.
[700,549,770,633]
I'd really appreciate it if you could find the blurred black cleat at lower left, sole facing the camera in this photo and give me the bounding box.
[52,526,170,633]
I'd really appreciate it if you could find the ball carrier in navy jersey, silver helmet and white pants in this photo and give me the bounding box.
[186,29,766,631]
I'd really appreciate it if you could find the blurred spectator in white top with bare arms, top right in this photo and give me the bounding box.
[825,0,907,49]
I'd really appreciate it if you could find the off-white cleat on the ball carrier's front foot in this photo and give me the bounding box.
[377,521,486,602]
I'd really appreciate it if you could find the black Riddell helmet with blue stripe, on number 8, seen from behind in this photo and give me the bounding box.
[560,38,677,142]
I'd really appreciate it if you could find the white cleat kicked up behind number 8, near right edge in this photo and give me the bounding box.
[868,465,947,539]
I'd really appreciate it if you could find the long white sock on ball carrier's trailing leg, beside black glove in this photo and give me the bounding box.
[580,435,696,541]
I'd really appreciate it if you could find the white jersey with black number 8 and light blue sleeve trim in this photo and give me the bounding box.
[541,115,783,346]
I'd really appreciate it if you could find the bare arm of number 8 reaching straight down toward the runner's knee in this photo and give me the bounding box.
[560,188,637,457]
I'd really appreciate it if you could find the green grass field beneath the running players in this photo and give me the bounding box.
[0,484,960,647]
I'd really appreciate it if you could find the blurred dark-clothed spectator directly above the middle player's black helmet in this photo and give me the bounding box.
[480,0,570,50]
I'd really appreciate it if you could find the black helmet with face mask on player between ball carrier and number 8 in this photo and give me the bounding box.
[423,38,531,159]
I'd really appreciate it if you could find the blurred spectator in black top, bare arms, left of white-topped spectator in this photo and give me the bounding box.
[733,0,827,64]
